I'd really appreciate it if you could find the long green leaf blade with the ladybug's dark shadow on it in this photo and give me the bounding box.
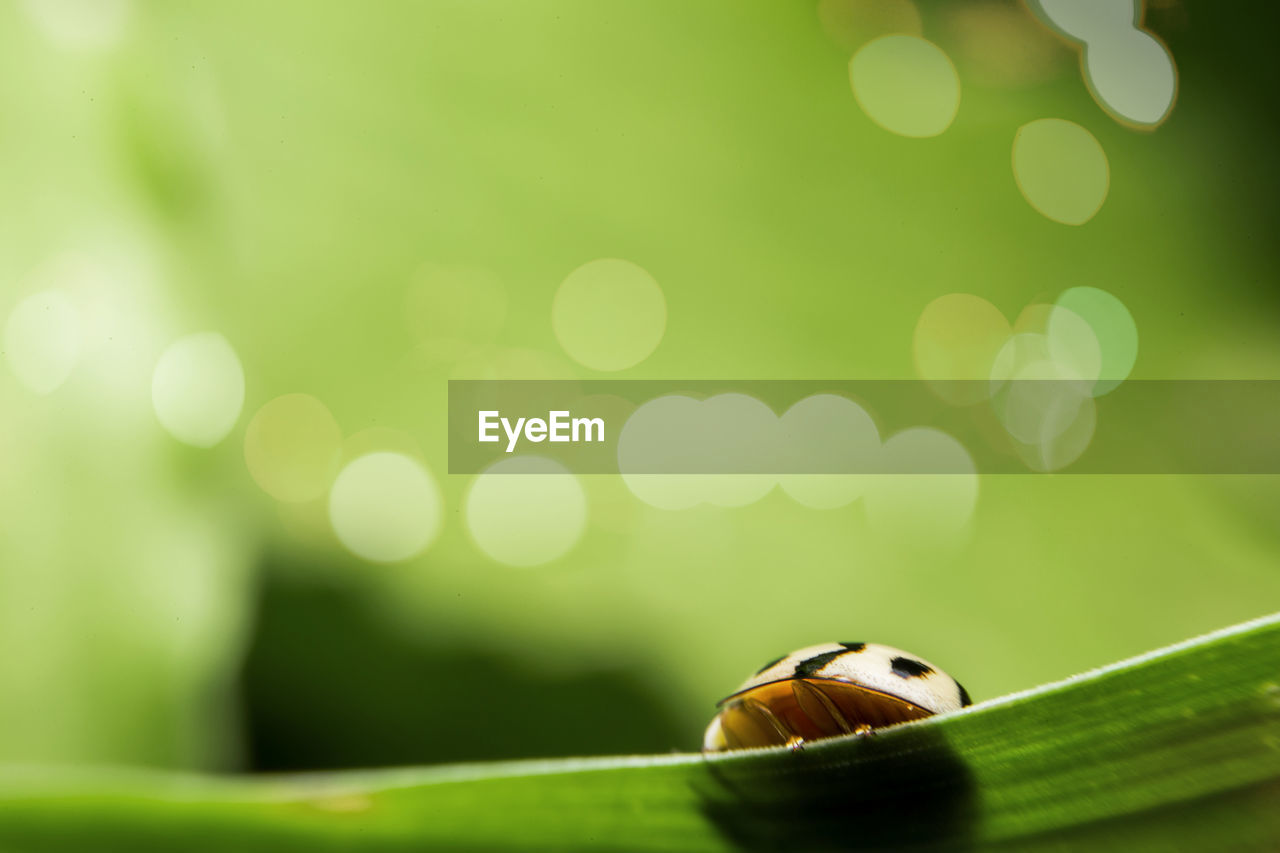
[0,615,1280,852]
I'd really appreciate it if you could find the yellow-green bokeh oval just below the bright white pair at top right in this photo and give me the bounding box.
[1014,118,1111,225]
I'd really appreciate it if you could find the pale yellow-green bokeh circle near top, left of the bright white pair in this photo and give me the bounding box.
[849,35,960,137]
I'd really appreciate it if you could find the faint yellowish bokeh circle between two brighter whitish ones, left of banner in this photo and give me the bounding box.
[244,394,342,502]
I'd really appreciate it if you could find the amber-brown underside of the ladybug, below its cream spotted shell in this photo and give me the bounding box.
[719,679,933,749]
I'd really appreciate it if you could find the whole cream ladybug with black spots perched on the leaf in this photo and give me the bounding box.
[703,643,972,751]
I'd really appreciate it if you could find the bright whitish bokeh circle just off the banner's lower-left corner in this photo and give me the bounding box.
[329,452,442,562]
